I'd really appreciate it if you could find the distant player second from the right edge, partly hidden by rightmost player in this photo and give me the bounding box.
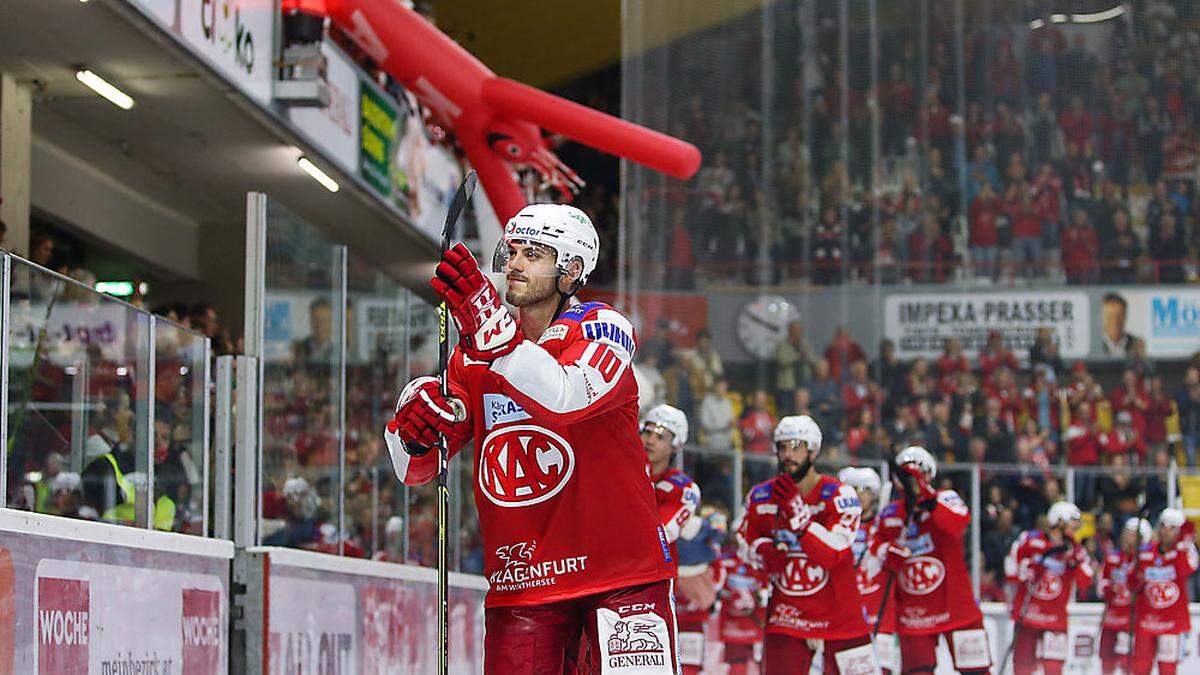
[1096,518,1154,674]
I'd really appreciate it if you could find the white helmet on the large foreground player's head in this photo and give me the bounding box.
[492,204,600,286]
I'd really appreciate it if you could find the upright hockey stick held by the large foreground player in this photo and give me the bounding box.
[438,171,476,675]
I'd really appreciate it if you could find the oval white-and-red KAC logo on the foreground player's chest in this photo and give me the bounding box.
[479,424,575,508]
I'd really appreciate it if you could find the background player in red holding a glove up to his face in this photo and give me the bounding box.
[880,446,991,674]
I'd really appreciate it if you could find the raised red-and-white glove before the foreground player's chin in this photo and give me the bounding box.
[430,244,524,362]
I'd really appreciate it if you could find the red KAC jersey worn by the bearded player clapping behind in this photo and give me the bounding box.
[738,476,870,640]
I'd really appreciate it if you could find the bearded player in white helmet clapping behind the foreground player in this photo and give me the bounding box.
[738,416,878,674]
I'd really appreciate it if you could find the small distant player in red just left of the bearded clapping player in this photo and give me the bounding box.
[718,555,767,675]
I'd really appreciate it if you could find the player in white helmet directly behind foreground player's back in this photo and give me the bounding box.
[641,404,720,675]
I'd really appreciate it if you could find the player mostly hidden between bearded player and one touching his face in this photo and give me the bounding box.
[838,467,900,675]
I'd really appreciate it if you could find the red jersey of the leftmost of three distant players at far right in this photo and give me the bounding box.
[1004,530,1096,633]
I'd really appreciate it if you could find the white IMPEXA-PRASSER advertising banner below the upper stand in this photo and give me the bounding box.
[884,289,1092,359]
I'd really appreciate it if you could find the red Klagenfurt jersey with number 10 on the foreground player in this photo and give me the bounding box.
[394,303,676,607]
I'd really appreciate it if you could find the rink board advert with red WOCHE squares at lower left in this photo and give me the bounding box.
[0,513,233,675]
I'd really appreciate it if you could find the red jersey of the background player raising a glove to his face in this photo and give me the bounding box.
[880,490,983,635]
